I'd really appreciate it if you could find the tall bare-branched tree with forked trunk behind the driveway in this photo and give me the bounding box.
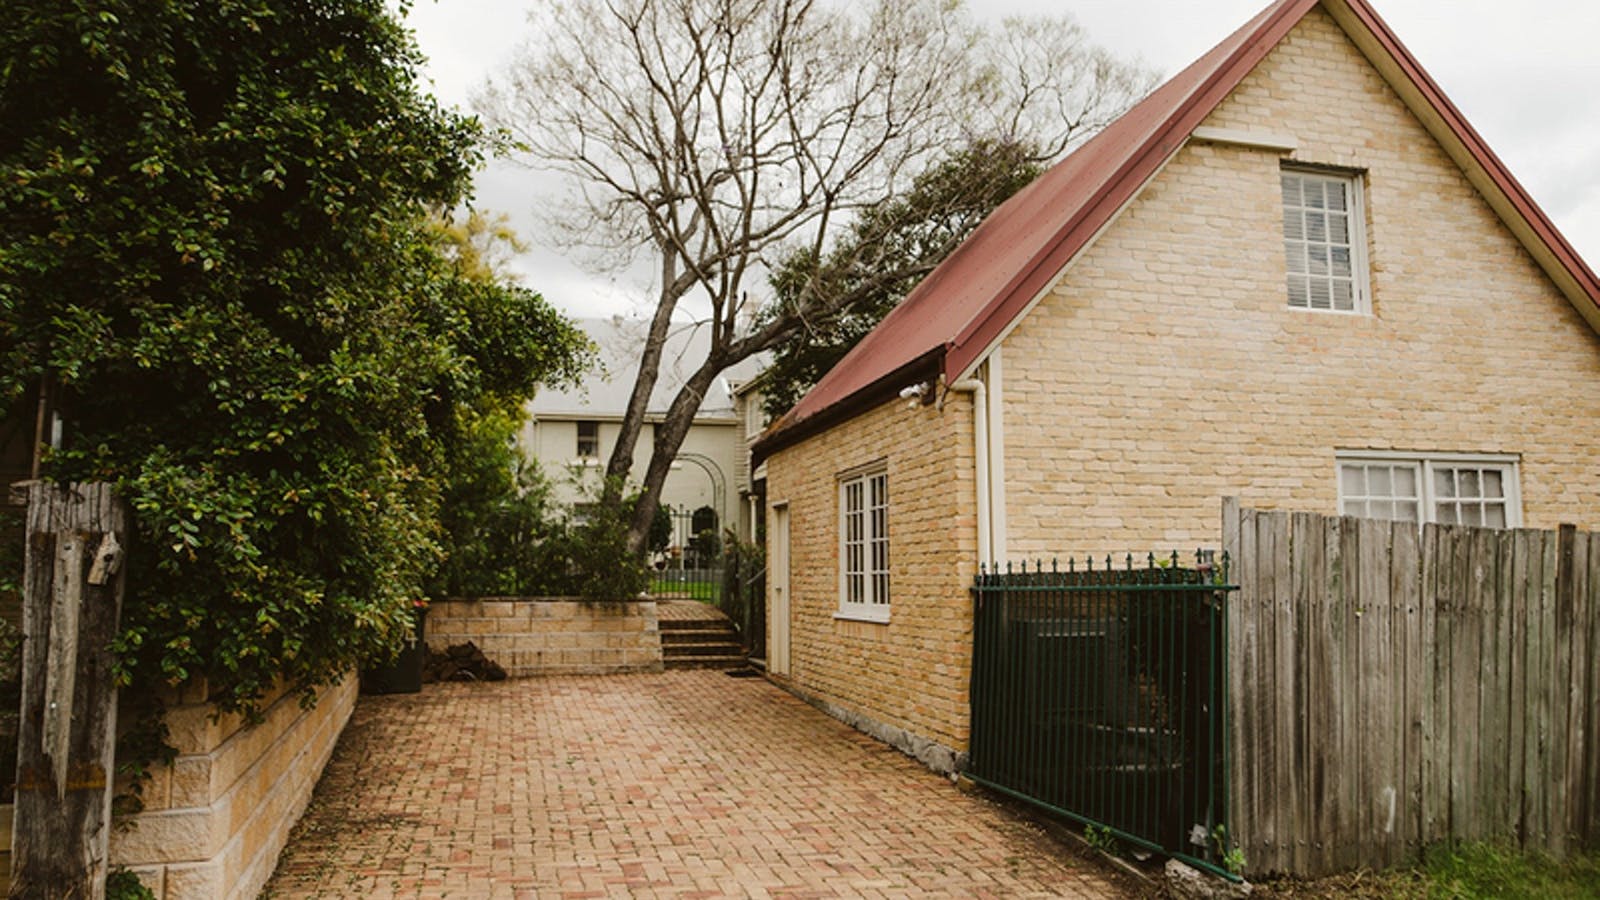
[483,0,1150,554]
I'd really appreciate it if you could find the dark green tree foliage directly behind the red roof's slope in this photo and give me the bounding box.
[763,138,1042,416]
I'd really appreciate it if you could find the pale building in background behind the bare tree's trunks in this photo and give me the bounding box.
[522,317,765,536]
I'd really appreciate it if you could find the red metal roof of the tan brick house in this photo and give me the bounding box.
[755,0,1600,458]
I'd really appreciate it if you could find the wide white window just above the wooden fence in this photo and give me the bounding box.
[1339,453,1522,528]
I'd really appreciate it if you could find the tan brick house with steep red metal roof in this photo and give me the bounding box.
[755,0,1600,769]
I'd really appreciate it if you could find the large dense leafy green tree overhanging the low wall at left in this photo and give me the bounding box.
[0,0,579,709]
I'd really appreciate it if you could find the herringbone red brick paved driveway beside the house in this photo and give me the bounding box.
[266,671,1123,900]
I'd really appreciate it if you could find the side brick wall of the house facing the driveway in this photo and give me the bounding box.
[766,394,976,753]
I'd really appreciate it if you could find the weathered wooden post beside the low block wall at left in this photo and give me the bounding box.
[10,482,128,900]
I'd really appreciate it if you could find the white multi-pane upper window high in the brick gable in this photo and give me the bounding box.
[1282,168,1371,312]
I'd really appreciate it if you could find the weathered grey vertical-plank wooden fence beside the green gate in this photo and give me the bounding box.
[1222,500,1600,876]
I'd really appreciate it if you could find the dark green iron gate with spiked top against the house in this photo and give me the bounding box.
[966,554,1237,874]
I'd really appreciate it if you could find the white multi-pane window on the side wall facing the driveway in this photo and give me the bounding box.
[834,461,891,623]
